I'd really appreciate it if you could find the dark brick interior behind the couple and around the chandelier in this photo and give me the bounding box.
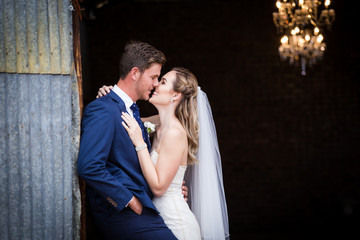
[81,0,360,239]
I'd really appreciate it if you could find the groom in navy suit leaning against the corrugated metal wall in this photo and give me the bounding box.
[78,42,176,240]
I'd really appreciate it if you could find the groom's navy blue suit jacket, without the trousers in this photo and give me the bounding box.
[78,91,157,214]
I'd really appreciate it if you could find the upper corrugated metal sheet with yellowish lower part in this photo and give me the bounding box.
[0,0,72,74]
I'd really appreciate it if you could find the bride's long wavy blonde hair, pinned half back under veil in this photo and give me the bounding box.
[171,67,199,164]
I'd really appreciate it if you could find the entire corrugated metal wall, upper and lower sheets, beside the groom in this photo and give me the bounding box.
[0,0,80,240]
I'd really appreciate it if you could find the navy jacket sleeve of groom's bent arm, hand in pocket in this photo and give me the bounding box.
[78,101,133,211]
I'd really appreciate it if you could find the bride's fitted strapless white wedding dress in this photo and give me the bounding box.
[150,150,201,240]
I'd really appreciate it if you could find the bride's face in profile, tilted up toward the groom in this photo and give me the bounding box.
[149,71,176,106]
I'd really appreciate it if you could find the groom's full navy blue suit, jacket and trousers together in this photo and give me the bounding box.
[78,91,176,239]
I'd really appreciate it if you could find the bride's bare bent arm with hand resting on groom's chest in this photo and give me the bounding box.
[122,114,187,196]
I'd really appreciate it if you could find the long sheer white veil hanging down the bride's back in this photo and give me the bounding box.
[186,87,230,240]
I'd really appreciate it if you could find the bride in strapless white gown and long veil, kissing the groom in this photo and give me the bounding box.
[98,68,229,240]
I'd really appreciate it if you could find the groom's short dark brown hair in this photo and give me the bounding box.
[119,41,166,79]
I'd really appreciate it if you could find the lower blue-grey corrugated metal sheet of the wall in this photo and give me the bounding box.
[0,74,77,239]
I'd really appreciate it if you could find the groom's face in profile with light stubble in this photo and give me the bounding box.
[136,63,162,101]
